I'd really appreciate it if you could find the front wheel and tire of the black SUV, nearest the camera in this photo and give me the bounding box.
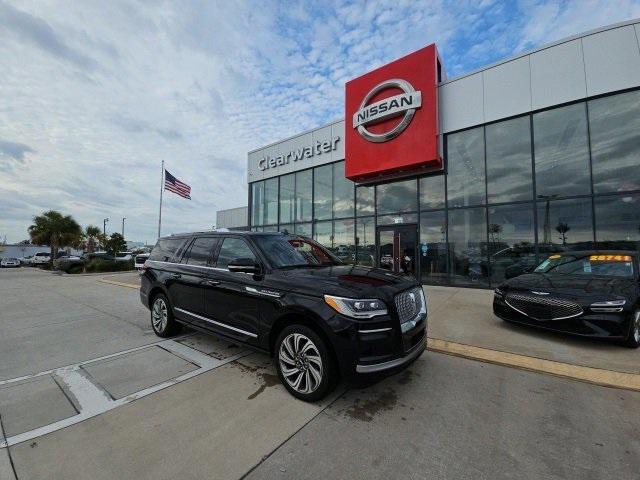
[274,325,338,402]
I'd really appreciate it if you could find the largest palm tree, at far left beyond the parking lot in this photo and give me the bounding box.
[29,210,82,262]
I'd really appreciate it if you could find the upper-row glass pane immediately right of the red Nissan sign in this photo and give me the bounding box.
[447,127,486,207]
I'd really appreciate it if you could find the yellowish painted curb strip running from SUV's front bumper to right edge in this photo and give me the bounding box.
[427,338,640,391]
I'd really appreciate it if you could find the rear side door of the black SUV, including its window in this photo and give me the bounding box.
[167,236,218,324]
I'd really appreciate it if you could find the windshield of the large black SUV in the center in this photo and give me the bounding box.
[255,235,342,268]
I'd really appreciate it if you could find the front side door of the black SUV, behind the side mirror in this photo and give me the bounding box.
[204,236,261,344]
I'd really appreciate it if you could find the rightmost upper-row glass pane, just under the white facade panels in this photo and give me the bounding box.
[589,91,640,193]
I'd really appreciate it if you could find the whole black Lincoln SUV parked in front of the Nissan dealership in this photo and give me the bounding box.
[140,231,427,401]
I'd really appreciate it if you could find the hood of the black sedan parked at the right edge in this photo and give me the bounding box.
[500,273,636,302]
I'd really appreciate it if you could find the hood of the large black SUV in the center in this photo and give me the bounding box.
[269,265,418,300]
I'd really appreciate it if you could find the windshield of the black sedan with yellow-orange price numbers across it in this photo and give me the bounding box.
[534,255,633,277]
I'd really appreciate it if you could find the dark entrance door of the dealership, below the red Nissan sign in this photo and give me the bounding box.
[378,225,418,277]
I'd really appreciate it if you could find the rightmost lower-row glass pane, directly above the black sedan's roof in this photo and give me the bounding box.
[595,195,640,250]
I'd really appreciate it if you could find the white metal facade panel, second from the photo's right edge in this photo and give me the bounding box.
[531,40,587,110]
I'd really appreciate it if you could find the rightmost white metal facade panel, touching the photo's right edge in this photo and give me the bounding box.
[582,25,640,96]
